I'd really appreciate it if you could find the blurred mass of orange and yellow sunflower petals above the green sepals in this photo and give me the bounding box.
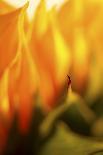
[0,0,103,154]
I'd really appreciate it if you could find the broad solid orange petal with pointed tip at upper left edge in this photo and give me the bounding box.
[0,6,25,75]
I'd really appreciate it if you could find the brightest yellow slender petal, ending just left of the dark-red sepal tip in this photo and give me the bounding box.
[50,11,71,84]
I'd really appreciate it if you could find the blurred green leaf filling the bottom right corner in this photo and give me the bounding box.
[39,124,103,155]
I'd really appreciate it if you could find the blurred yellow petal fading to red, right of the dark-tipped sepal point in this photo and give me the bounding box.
[73,28,90,93]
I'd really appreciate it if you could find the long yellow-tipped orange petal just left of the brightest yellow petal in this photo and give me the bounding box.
[31,1,54,109]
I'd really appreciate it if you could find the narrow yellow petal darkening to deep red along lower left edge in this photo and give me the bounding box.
[0,69,10,154]
